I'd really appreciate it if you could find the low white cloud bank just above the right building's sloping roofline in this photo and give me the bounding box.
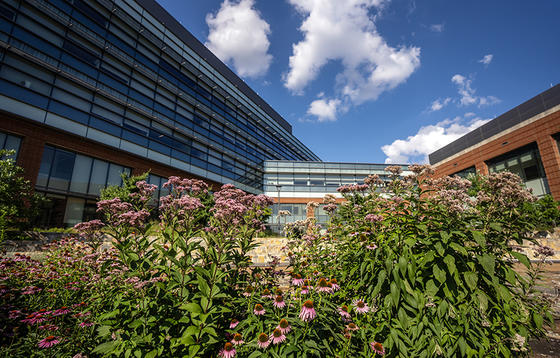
[381,117,489,164]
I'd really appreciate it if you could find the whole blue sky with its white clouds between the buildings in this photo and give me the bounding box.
[154,0,560,163]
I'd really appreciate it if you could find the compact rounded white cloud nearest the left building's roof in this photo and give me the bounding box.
[206,0,272,77]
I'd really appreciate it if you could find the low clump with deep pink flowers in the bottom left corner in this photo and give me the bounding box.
[0,240,124,357]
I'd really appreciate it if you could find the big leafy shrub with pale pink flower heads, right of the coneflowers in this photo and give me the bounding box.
[286,166,558,357]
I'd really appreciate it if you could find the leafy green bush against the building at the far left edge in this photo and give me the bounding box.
[0,149,46,243]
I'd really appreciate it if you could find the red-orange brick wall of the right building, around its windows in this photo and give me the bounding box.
[434,107,560,200]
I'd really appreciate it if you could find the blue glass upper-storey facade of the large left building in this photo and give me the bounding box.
[0,0,320,192]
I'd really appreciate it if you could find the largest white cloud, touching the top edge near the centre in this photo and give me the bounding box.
[284,0,420,120]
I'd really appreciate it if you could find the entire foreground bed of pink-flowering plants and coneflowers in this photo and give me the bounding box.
[0,166,558,358]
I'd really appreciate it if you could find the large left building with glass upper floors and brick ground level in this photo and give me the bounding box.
[0,0,319,225]
